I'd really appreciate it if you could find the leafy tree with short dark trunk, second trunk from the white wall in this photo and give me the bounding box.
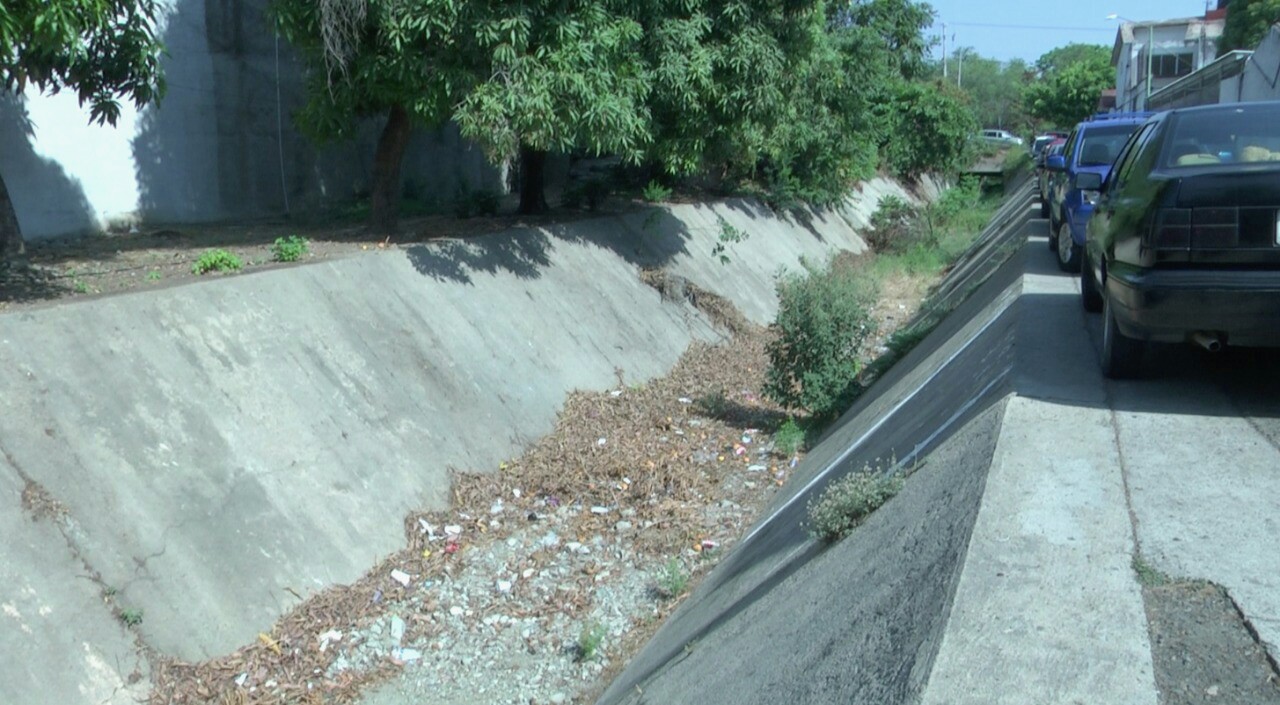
[454,0,650,214]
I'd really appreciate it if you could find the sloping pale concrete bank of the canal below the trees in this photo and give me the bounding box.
[0,179,908,702]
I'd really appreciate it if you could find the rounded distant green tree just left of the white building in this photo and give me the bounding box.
[1027,45,1115,127]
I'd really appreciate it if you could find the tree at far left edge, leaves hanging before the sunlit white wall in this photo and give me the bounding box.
[0,0,164,264]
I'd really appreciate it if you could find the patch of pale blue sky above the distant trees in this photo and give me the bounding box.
[927,0,1217,61]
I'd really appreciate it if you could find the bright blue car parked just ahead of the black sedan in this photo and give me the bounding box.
[1042,113,1152,273]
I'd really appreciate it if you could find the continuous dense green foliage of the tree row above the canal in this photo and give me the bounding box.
[275,0,950,223]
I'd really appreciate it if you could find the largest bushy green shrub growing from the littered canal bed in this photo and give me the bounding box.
[764,262,876,420]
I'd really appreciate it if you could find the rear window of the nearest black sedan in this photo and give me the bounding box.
[1162,105,1280,169]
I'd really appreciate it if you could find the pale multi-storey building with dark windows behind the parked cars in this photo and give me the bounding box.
[1111,4,1226,111]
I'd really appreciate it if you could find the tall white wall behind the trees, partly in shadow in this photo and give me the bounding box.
[0,0,502,239]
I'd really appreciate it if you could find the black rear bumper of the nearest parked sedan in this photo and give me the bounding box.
[1107,265,1280,347]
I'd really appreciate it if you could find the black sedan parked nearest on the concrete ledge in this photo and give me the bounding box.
[1080,102,1280,377]
